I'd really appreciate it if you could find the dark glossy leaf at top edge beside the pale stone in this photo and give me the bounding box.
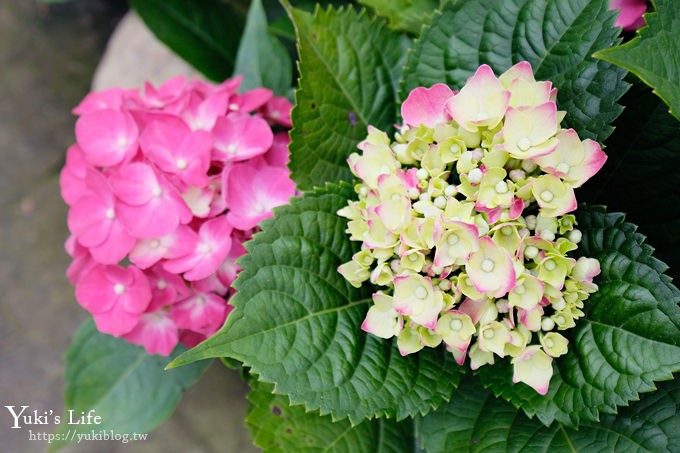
[129,0,245,82]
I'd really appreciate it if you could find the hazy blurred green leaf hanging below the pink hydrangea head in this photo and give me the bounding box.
[55,320,210,447]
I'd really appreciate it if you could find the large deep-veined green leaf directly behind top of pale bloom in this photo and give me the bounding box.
[402,0,627,142]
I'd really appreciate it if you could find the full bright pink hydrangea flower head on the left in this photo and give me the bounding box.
[60,77,295,355]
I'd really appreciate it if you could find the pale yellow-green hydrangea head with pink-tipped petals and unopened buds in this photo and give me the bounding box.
[338,62,606,394]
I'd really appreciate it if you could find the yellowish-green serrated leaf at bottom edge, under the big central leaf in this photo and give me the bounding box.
[246,379,415,453]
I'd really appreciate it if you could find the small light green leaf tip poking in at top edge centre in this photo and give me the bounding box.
[359,0,439,35]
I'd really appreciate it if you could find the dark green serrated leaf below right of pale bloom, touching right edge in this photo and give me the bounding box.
[478,208,680,426]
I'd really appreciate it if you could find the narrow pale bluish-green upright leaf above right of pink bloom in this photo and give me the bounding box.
[234,0,293,96]
